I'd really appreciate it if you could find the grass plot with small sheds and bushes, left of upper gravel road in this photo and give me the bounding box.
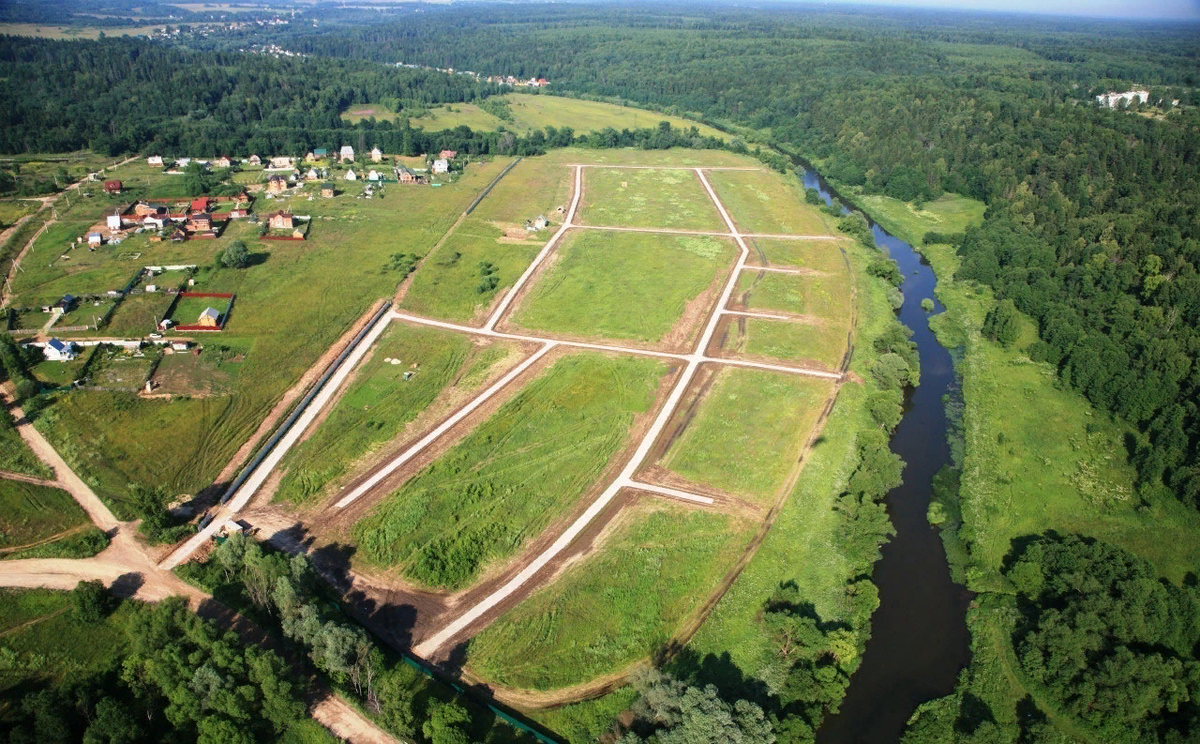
[401,158,575,324]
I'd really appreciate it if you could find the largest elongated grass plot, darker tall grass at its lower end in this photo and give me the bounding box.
[354,353,667,589]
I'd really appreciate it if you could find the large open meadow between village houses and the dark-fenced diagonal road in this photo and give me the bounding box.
[22,161,506,518]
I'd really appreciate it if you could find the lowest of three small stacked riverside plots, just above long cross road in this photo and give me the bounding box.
[715,316,850,370]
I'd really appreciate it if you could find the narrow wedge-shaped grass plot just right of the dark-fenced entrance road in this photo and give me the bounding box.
[275,323,528,503]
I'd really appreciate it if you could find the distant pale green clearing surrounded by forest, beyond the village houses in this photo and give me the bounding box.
[342,94,730,139]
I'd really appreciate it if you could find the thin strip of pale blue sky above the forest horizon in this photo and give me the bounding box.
[827,0,1200,20]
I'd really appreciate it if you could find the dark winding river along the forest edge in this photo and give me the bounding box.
[803,168,971,744]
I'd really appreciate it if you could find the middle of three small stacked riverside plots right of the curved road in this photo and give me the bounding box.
[730,269,850,320]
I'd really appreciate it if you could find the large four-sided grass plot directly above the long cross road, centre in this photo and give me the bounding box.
[512,230,733,346]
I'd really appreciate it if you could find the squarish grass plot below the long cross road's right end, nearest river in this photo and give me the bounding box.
[660,367,832,503]
